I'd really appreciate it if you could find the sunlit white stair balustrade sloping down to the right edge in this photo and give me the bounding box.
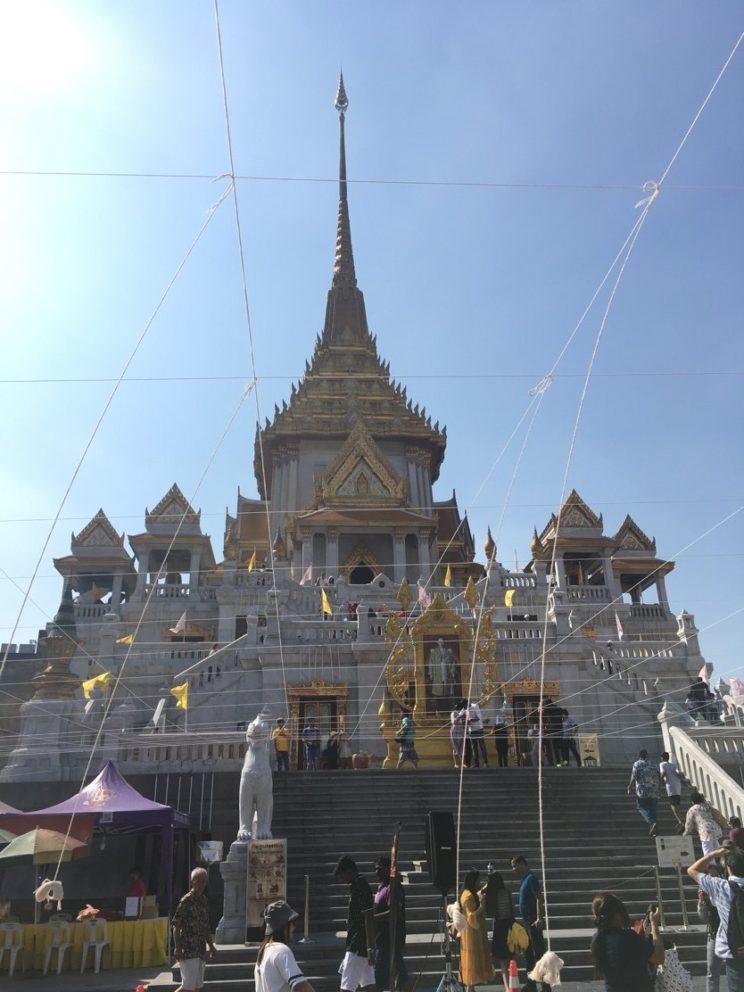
[659,706,744,818]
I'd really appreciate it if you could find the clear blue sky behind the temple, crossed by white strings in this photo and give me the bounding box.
[0,0,744,674]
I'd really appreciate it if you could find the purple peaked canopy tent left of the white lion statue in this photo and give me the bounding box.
[0,761,189,916]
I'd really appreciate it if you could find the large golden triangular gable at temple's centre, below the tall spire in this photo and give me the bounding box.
[318,424,406,506]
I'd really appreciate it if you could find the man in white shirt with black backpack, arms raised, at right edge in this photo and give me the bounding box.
[687,847,744,992]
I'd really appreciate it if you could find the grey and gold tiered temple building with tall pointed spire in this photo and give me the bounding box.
[0,79,704,781]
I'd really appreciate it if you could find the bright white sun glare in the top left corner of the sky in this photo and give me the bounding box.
[0,0,95,97]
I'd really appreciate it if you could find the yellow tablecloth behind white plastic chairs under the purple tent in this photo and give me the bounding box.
[23,917,168,972]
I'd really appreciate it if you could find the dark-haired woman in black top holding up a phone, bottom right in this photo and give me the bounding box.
[592,892,664,992]
